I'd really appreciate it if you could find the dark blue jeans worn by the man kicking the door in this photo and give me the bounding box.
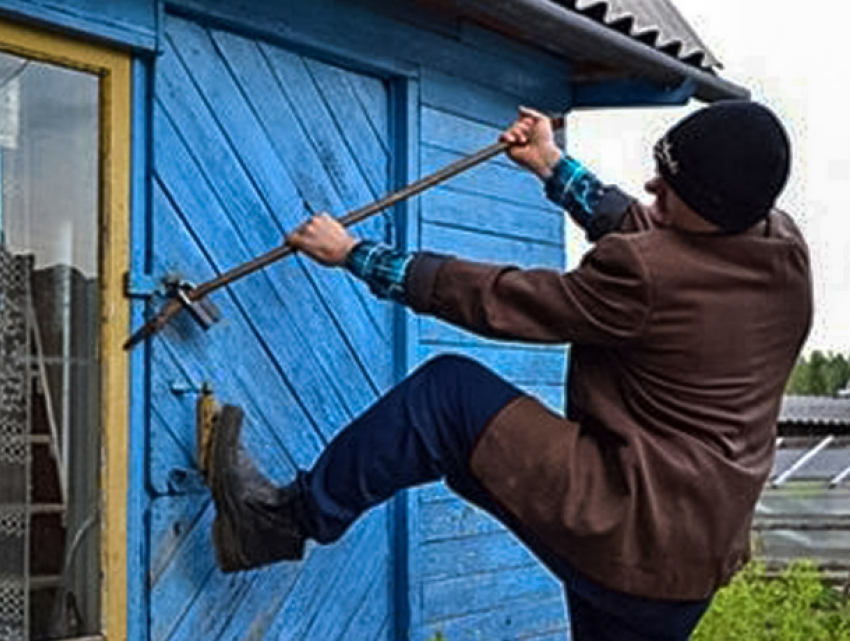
[297,356,709,641]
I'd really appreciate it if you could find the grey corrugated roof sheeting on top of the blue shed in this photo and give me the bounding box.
[554,0,722,71]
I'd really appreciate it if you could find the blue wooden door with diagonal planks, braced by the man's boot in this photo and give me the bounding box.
[148,15,394,641]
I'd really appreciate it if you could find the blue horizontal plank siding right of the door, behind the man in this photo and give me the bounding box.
[408,71,565,641]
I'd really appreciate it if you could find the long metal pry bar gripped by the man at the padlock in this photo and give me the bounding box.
[124,117,564,350]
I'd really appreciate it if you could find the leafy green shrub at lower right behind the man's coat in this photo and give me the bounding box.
[692,561,850,641]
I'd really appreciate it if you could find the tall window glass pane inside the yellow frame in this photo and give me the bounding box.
[0,47,101,640]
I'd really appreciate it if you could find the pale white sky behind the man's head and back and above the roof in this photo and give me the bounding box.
[567,0,850,354]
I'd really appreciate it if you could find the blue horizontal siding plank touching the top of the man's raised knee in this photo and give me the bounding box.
[419,344,565,385]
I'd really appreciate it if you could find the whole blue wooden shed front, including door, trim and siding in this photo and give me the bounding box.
[0,0,570,641]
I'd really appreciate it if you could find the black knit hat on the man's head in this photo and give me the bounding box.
[654,100,791,233]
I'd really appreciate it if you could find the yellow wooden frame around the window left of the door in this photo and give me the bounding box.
[0,20,132,640]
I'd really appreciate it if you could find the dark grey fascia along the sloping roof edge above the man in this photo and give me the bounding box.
[453,0,750,102]
